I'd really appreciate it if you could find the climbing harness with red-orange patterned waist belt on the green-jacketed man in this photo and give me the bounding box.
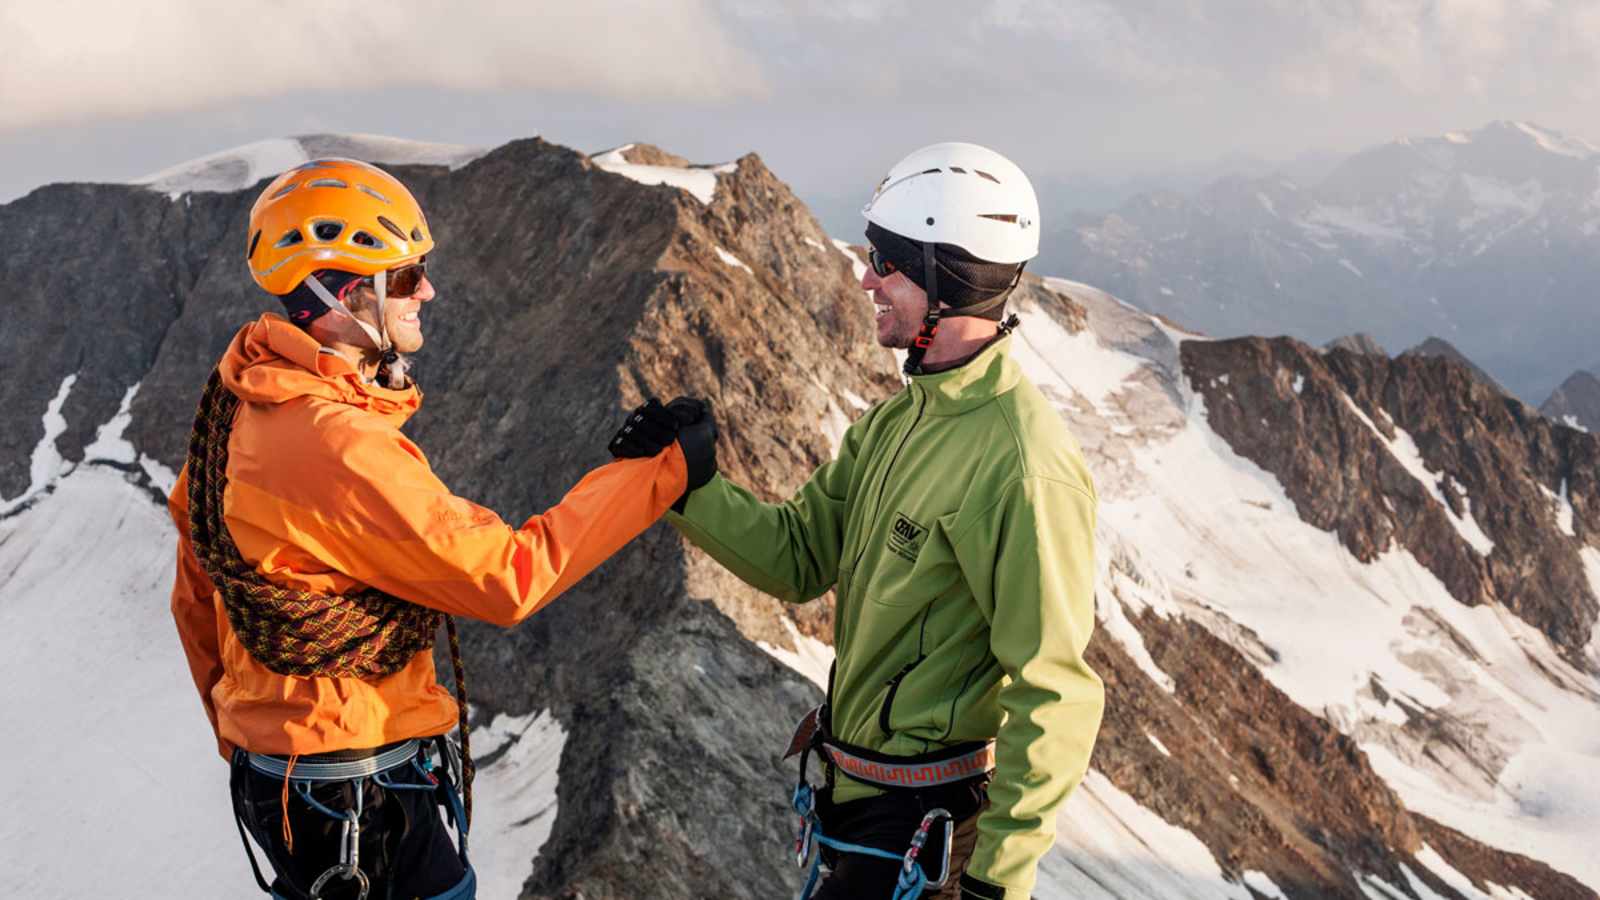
[786,705,994,900]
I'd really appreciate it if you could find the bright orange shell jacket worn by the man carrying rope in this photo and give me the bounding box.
[168,314,686,757]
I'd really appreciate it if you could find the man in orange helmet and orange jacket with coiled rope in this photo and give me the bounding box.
[168,160,709,900]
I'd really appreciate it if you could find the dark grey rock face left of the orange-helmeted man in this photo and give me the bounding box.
[0,184,250,498]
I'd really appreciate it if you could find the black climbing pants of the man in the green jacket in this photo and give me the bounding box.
[811,778,989,900]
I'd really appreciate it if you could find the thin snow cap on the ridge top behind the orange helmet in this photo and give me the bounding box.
[133,135,488,195]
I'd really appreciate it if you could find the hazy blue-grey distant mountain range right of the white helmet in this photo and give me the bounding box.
[1038,122,1600,402]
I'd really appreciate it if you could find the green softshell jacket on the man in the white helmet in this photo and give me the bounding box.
[670,338,1104,900]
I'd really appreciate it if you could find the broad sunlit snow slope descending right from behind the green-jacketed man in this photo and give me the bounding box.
[1018,282,1600,889]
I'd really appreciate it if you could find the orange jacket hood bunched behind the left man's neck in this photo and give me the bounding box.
[218,312,422,428]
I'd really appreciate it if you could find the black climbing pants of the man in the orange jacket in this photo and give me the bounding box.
[230,751,472,900]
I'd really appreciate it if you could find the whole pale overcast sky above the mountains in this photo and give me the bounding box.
[0,0,1600,227]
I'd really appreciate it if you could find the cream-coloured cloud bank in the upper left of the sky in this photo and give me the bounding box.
[0,0,770,130]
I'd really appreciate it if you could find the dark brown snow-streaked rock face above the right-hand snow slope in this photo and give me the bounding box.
[1182,338,1600,666]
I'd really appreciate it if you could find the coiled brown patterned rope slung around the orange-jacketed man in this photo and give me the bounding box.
[184,366,475,823]
